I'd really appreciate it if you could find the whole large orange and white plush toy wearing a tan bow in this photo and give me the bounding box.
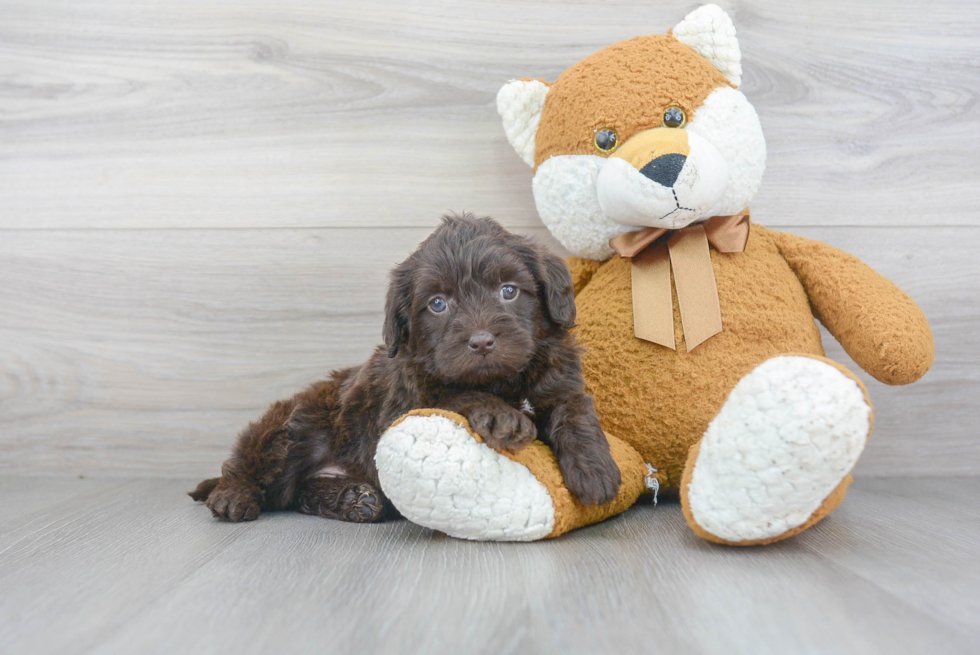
[377,5,933,545]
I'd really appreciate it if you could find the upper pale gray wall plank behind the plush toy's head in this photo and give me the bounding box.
[0,0,980,228]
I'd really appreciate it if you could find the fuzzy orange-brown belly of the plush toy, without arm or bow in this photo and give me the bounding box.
[576,234,823,488]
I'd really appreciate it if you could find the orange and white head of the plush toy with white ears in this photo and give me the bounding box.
[497,5,766,259]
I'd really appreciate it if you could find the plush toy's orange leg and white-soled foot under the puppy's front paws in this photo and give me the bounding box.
[375,409,647,541]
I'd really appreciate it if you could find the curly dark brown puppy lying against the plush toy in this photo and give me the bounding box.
[190,214,620,522]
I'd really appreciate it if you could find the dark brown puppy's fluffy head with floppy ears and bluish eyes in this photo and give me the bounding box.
[385,216,575,385]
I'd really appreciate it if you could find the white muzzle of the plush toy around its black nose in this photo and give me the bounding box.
[596,128,728,229]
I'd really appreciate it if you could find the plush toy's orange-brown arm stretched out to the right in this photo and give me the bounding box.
[771,232,935,384]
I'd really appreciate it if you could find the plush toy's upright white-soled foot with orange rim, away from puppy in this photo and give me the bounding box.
[681,355,871,545]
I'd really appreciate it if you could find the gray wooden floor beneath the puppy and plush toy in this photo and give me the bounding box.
[0,477,980,655]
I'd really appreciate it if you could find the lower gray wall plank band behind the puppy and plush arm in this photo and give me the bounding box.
[0,228,980,476]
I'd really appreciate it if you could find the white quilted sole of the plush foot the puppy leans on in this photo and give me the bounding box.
[375,410,555,541]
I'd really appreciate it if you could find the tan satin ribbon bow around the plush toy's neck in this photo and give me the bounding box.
[609,209,750,352]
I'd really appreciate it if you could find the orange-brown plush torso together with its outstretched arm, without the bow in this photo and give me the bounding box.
[573,225,933,489]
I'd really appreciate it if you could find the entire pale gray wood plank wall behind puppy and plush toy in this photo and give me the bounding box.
[0,0,980,476]
